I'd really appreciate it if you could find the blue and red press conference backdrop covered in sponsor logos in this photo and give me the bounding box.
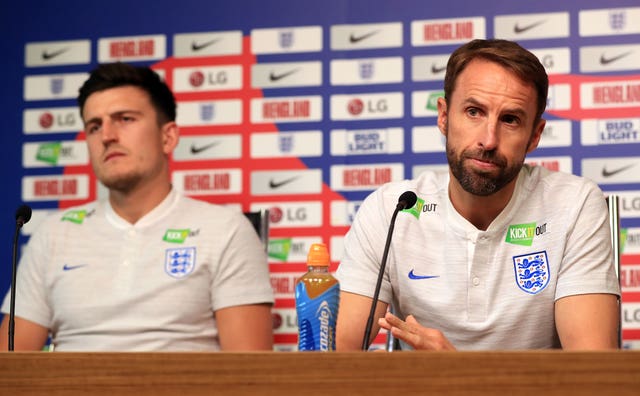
[0,0,640,350]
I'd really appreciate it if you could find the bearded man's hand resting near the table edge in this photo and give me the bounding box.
[378,312,456,351]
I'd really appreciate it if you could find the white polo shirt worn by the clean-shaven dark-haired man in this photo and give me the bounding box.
[2,191,273,351]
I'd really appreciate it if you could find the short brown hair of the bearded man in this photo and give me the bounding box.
[444,39,549,122]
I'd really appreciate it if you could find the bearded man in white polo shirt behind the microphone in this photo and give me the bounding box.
[336,40,620,350]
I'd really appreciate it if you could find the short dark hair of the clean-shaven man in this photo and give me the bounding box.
[78,62,176,125]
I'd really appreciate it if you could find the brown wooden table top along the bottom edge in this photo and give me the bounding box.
[0,351,640,396]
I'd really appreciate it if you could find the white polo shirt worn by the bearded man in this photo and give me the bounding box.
[337,165,620,350]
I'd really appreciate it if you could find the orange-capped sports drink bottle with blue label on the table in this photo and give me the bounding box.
[295,243,340,351]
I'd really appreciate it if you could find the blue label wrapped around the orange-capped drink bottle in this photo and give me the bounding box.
[296,282,340,351]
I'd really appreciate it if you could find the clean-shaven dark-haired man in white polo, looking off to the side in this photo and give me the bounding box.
[0,63,273,351]
